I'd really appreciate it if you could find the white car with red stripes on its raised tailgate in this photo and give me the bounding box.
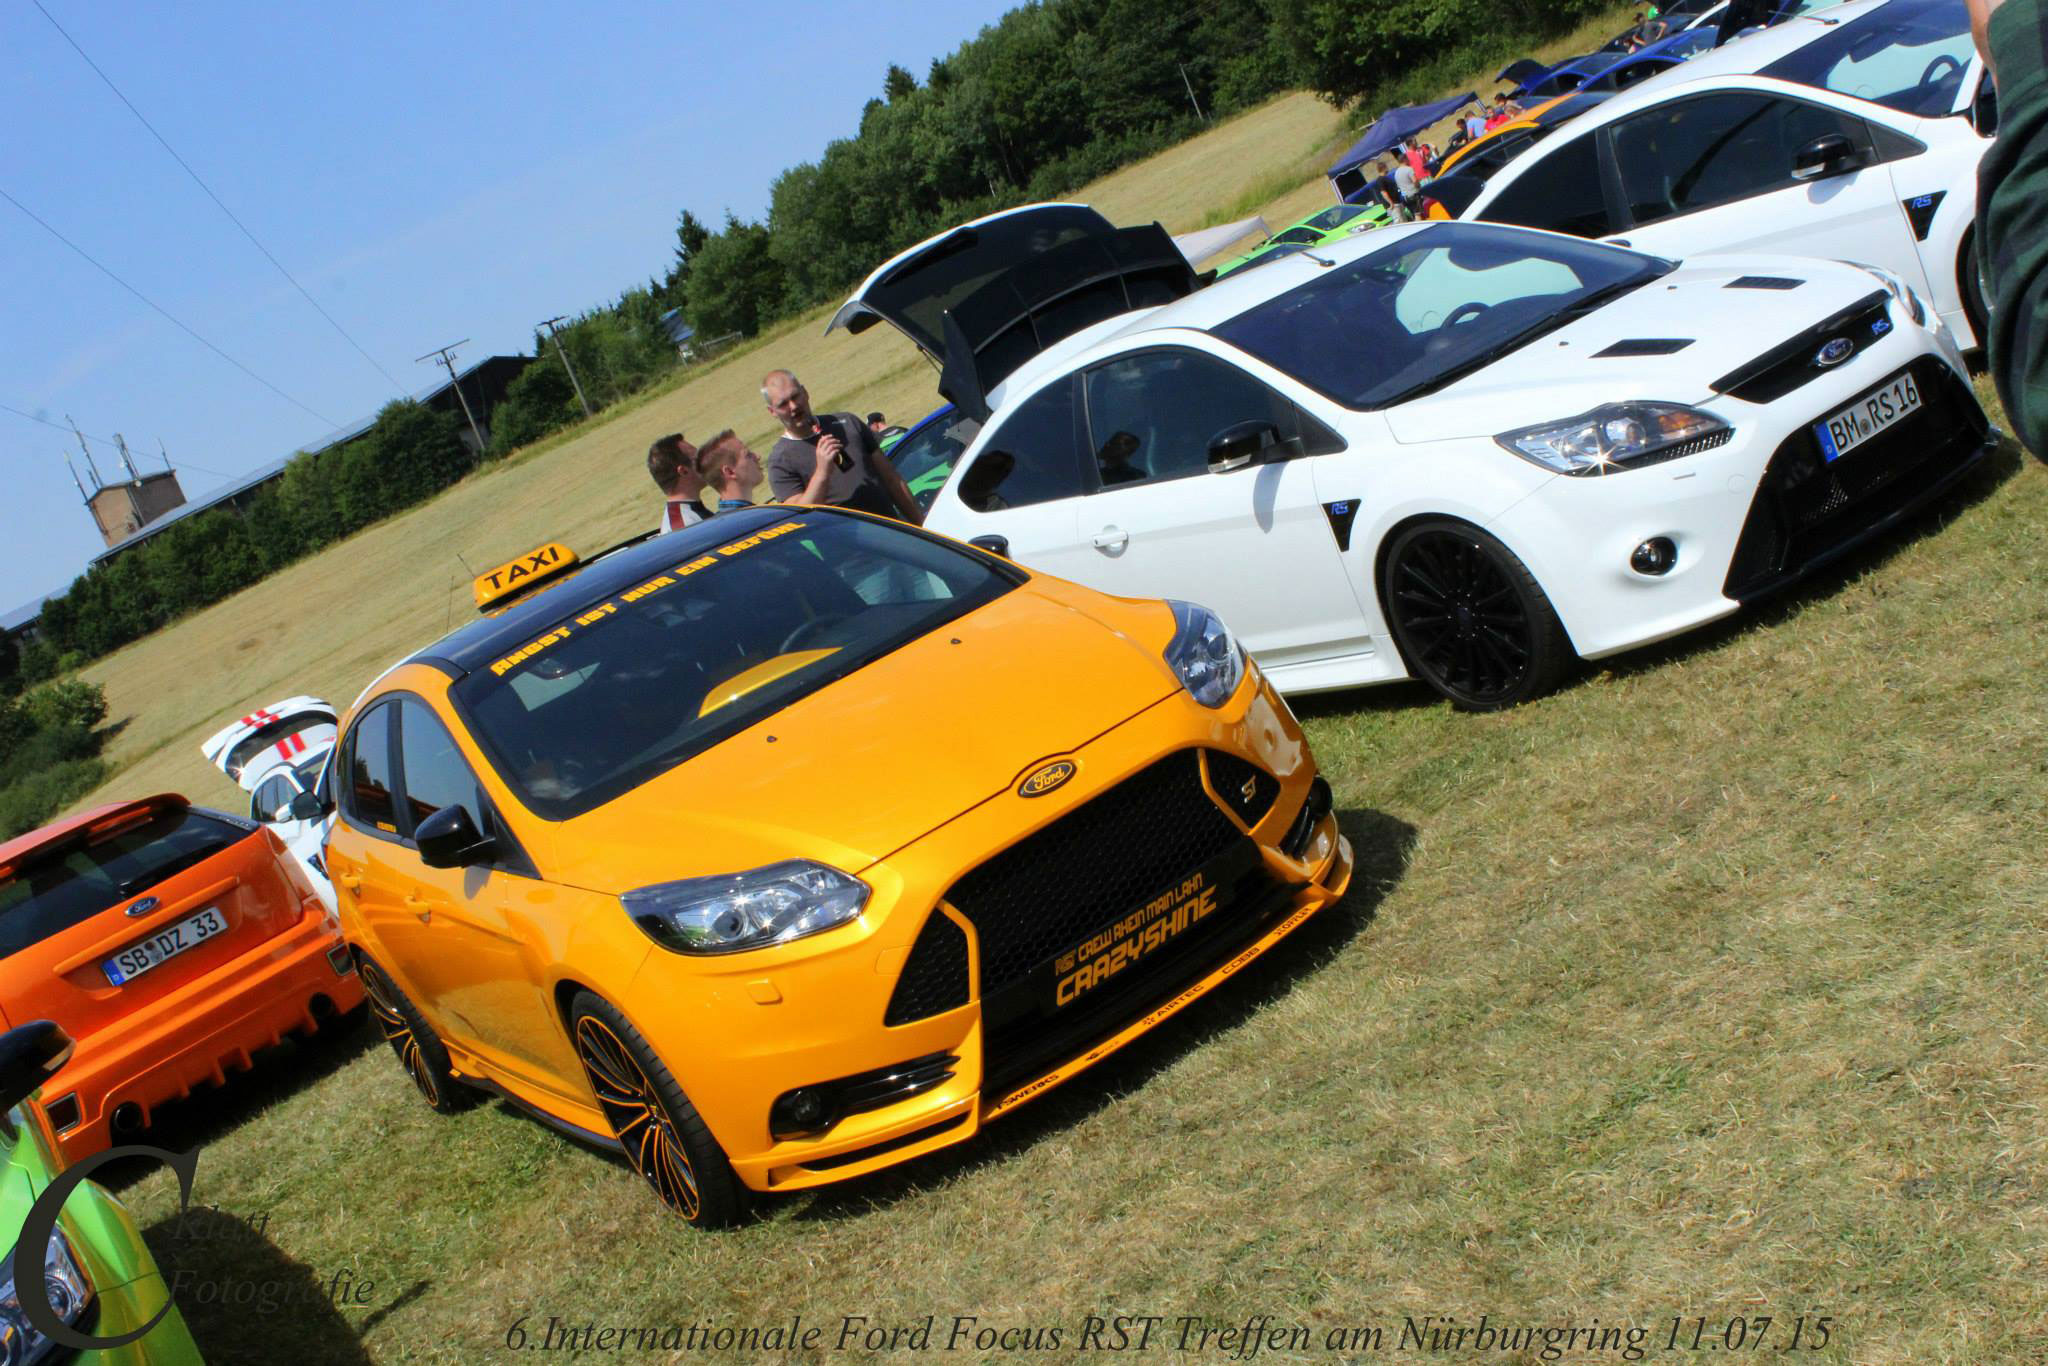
[199,696,336,913]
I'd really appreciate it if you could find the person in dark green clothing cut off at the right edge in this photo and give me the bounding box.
[1968,0,2048,459]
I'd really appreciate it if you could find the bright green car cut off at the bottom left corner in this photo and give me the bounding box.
[0,1020,201,1366]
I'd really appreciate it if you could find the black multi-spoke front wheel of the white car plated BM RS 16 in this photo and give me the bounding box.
[1382,518,1573,711]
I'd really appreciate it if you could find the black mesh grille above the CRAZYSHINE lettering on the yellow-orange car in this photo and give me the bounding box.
[946,750,1249,1001]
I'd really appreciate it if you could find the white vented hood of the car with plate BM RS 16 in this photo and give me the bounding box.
[1386,256,1880,442]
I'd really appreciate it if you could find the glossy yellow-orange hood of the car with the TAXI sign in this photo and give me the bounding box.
[551,580,1180,893]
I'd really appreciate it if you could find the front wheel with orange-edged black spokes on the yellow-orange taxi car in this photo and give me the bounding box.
[569,991,748,1229]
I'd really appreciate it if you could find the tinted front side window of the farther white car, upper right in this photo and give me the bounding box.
[1614,92,1870,223]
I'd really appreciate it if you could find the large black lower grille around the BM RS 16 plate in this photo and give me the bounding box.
[1722,356,1989,602]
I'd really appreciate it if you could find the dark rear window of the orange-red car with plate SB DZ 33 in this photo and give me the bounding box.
[0,807,252,956]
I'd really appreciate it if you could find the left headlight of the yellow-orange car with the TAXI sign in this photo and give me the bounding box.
[618,858,868,954]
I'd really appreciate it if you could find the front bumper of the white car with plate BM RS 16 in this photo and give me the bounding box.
[1489,326,1993,659]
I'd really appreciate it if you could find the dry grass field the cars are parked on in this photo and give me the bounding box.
[56,15,2048,1366]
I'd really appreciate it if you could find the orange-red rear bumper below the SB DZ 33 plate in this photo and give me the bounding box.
[43,909,362,1163]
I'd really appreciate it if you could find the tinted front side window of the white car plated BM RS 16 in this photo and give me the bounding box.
[1085,350,1294,489]
